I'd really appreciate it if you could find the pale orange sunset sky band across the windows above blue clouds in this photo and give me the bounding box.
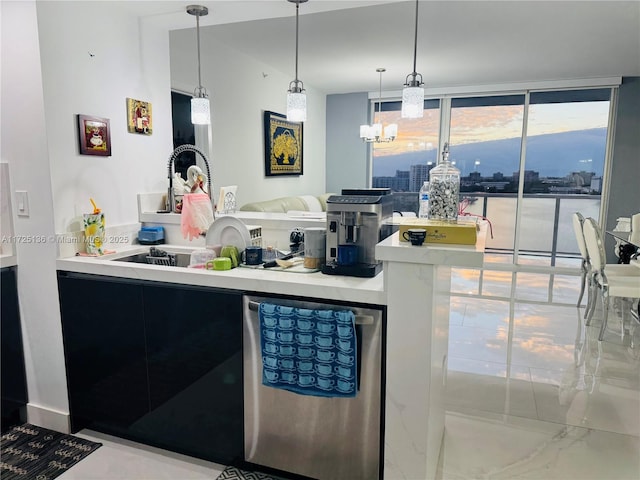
[375,102,609,156]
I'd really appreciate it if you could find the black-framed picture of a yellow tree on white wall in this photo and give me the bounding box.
[264,111,302,177]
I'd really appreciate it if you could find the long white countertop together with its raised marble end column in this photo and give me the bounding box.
[57,222,486,479]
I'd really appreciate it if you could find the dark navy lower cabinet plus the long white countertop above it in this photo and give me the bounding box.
[57,245,385,470]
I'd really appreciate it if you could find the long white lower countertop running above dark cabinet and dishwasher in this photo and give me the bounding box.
[56,245,386,305]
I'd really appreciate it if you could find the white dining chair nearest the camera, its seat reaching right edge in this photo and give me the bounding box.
[582,218,640,340]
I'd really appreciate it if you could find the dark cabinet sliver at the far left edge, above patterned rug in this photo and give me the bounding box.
[0,267,27,432]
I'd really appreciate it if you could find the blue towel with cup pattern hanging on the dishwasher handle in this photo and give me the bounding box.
[258,302,358,398]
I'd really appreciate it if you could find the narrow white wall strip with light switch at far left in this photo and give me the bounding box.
[0,1,69,430]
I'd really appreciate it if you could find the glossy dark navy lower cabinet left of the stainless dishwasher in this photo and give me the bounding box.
[58,272,243,464]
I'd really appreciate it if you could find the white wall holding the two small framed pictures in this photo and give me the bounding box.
[38,1,173,232]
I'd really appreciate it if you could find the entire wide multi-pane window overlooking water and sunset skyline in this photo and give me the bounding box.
[372,83,612,274]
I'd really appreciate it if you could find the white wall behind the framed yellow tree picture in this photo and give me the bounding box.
[170,29,326,206]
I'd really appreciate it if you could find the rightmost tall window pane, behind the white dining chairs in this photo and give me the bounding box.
[518,89,611,266]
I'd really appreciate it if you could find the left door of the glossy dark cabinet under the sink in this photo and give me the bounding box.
[58,272,149,434]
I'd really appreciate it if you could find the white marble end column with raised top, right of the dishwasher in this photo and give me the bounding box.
[376,226,486,479]
